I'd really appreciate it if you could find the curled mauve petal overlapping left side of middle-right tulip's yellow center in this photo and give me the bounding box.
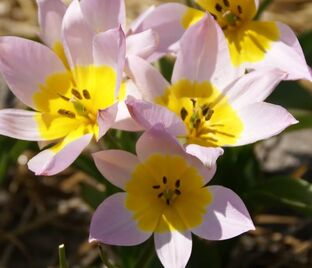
[126,97,186,136]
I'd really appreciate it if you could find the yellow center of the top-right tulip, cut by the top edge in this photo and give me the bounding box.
[181,0,280,66]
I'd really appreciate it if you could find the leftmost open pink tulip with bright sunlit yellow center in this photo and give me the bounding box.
[0,0,126,175]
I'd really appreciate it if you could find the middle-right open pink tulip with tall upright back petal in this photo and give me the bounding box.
[127,15,297,162]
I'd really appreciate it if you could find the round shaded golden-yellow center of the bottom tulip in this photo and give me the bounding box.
[126,154,212,233]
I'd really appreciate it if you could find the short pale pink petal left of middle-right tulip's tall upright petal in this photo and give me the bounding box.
[126,56,169,102]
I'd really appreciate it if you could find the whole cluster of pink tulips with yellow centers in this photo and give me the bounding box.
[0,0,312,267]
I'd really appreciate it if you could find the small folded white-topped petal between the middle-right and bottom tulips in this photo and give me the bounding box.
[185,144,224,184]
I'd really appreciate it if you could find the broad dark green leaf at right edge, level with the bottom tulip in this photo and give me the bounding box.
[247,176,312,217]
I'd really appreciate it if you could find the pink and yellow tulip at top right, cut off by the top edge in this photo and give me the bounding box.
[141,0,312,80]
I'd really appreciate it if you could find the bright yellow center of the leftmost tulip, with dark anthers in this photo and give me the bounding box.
[33,65,124,149]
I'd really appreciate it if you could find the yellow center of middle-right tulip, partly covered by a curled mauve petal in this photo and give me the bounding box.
[155,80,243,147]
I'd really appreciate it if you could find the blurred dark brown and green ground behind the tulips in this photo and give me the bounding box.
[0,0,312,268]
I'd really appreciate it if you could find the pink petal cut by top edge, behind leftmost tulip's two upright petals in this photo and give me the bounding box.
[80,0,126,32]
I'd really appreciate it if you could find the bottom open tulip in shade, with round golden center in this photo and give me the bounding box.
[90,125,254,268]
